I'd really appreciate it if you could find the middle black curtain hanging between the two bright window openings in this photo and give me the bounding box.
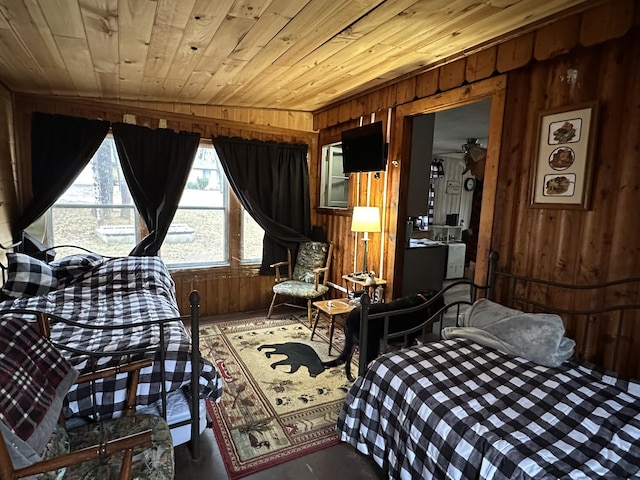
[112,123,200,256]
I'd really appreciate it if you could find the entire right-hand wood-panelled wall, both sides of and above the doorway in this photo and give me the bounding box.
[314,0,640,377]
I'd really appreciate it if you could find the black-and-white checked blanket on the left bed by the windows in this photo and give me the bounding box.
[0,257,222,418]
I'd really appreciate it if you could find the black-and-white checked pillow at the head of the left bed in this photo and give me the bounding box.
[2,253,58,298]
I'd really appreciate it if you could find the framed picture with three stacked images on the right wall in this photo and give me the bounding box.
[531,102,597,210]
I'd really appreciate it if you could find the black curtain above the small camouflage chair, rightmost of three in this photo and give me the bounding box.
[212,137,312,275]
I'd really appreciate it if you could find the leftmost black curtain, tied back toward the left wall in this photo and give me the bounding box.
[12,112,109,241]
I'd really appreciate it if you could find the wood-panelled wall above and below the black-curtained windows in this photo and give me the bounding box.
[11,95,317,315]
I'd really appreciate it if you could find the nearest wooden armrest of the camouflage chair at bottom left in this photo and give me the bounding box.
[13,429,152,478]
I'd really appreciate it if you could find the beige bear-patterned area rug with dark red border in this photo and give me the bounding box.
[200,313,357,479]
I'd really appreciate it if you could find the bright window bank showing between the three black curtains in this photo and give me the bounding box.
[46,136,264,267]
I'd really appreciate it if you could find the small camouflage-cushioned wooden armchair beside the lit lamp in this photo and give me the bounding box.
[267,242,333,326]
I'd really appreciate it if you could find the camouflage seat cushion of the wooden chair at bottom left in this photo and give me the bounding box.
[64,414,174,480]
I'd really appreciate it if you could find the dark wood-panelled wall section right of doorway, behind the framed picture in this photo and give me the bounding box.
[492,30,640,377]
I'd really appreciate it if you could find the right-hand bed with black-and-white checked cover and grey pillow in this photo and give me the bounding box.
[337,253,640,479]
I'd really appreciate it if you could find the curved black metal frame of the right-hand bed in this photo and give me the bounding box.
[358,251,640,376]
